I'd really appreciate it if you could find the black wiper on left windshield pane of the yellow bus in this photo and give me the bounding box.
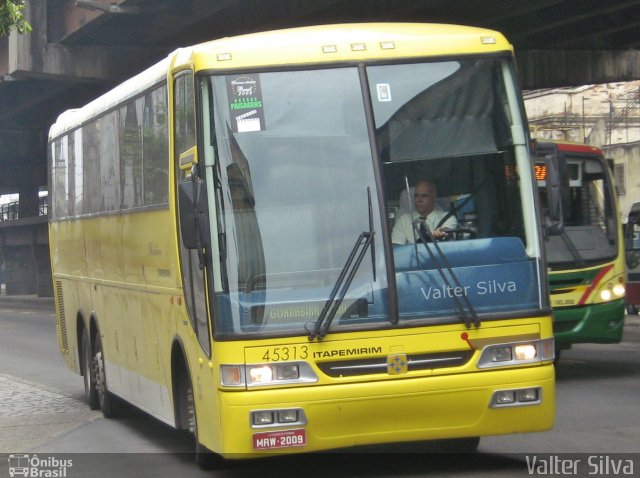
[309,188,376,341]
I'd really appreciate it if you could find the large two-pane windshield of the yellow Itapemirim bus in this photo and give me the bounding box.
[205,59,541,337]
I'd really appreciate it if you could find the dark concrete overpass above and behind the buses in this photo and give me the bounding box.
[0,0,640,295]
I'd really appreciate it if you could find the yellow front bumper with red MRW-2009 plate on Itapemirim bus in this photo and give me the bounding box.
[211,364,555,458]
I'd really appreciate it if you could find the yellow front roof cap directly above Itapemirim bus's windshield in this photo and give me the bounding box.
[176,23,512,69]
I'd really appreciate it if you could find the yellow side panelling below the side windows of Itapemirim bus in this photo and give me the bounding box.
[50,209,186,422]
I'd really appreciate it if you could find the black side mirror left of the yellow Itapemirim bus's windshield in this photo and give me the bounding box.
[178,177,210,250]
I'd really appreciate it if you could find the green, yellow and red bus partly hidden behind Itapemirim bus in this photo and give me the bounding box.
[536,141,626,361]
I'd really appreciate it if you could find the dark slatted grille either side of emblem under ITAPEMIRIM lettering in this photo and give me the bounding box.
[317,350,474,377]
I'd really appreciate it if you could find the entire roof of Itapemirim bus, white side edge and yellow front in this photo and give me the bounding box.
[49,23,513,140]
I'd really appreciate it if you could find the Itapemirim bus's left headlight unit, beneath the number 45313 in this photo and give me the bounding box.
[220,362,318,388]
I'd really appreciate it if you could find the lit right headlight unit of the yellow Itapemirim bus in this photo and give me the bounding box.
[478,338,555,368]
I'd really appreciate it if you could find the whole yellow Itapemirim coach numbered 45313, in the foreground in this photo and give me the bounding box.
[49,23,555,465]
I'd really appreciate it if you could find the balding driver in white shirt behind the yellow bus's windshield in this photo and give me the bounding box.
[391,180,458,244]
